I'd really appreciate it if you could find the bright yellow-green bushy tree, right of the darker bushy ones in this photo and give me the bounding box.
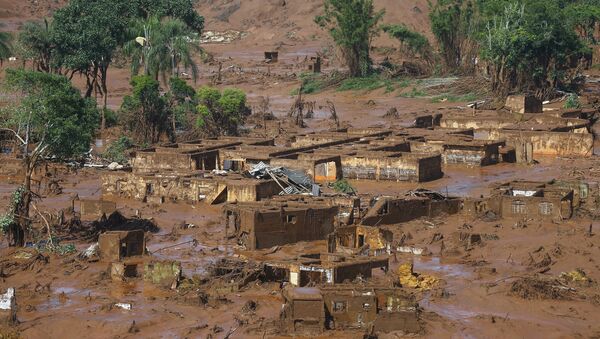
[196,86,250,135]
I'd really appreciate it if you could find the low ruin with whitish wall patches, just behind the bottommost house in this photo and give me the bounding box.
[265,253,389,287]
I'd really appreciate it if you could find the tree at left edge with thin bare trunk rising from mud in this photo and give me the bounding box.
[0,69,98,246]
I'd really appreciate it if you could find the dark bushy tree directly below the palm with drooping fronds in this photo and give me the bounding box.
[120,75,172,144]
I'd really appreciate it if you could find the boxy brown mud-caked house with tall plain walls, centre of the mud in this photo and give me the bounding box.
[224,201,339,250]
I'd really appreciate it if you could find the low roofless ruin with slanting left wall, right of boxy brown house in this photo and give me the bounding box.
[361,190,463,226]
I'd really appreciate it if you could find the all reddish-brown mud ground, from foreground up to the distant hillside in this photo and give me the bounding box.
[0,1,600,338]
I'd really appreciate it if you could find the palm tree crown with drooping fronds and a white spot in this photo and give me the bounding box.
[123,17,202,82]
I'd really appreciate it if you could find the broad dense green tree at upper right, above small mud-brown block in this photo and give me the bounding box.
[481,0,585,98]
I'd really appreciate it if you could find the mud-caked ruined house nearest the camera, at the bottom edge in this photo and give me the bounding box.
[281,285,421,333]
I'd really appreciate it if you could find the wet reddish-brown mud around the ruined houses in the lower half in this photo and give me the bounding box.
[0,155,600,338]
